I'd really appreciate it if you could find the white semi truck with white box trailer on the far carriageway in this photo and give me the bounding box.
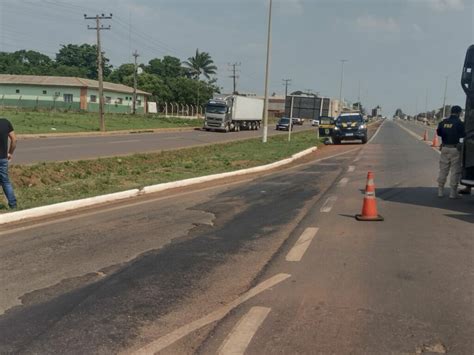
[204,95,263,132]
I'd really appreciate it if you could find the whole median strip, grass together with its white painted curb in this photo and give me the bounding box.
[0,132,319,224]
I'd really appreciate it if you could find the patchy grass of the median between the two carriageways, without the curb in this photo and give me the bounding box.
[3,131,320,212]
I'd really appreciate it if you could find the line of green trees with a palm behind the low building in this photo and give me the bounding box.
[0,44,219,105]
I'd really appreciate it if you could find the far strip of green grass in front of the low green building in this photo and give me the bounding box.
[0,109,203,134]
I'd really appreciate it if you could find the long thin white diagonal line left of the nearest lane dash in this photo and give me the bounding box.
[132,274,291,355]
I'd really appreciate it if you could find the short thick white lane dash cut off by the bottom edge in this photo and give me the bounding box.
[218,306,271,355]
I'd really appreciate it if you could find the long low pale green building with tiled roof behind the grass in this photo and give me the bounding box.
[0,74,151,113]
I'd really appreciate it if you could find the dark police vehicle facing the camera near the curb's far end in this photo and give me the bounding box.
[333,113,368,144]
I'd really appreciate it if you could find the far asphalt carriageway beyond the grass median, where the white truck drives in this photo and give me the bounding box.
[12,124,315,164]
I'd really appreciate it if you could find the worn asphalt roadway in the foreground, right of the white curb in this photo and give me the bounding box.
[0,121,474,354]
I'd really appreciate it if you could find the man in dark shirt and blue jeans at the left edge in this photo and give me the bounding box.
[0,118,16,208]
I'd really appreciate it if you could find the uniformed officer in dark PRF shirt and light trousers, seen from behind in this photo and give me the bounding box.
[436,106,466,198]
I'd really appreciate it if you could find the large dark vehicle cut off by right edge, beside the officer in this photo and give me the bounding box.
[461,45,474,187]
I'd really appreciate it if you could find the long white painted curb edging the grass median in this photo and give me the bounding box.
[0,147,318,225]
